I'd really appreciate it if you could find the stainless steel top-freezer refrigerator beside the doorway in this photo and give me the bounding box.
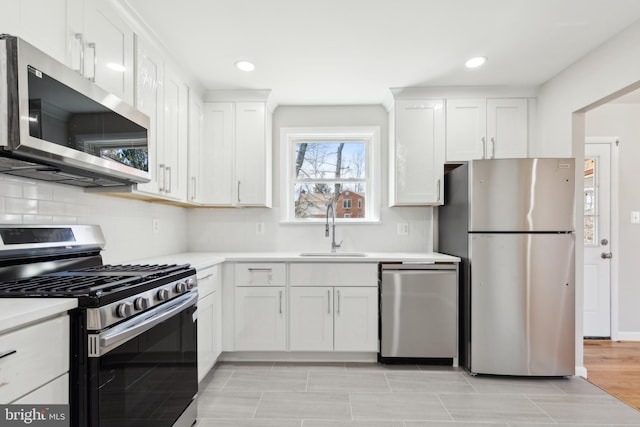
[438,158,575,376]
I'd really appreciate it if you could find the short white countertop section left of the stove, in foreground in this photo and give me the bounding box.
[0,298,78,334]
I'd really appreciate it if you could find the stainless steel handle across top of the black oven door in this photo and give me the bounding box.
[89,292,198,357]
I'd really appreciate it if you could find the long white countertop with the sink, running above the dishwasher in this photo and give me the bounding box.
[131,252,460,270]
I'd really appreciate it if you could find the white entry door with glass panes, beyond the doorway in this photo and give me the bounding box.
[583,140,613,337]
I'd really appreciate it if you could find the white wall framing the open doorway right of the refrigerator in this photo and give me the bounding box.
[530,22,640,374]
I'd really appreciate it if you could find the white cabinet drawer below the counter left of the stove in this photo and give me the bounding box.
[0,316,69,403]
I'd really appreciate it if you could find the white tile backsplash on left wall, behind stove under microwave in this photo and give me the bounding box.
[0,175,187,264]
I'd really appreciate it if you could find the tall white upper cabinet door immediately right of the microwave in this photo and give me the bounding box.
[136,37,164,194]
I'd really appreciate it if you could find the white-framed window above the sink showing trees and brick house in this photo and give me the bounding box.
[281,127,380,222]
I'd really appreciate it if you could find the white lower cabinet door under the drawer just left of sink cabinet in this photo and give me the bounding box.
[234,286,287,351]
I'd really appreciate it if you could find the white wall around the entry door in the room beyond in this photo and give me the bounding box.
[585,104,640,340]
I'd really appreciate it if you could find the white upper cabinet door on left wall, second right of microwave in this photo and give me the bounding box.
[159,69,189,200]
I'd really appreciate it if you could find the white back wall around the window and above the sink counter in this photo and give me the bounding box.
[188,105,433,252]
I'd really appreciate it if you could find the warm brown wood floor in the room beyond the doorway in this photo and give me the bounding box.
[584,340,640,410]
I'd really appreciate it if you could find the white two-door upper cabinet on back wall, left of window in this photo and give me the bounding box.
[201,101,271,207]
